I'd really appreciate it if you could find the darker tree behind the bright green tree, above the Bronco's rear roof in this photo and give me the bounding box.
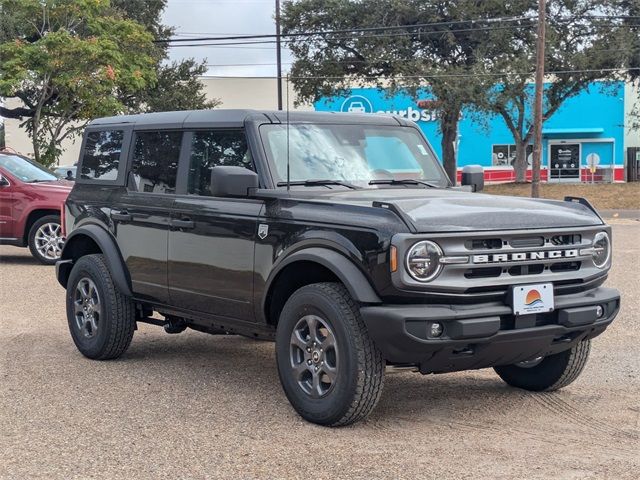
[111,0,220,113]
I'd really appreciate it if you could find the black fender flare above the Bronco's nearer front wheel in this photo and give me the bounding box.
[262,247,382,307]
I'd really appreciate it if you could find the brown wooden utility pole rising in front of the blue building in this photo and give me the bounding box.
[531,0,547,198]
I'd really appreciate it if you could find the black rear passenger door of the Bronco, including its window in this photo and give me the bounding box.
[110,130,183,303]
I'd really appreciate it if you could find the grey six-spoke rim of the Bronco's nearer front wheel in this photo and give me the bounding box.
[289,315,338,398]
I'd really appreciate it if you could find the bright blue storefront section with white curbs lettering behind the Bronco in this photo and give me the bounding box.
[314,82,640,182]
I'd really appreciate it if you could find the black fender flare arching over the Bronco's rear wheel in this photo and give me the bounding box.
[56,224,132,296]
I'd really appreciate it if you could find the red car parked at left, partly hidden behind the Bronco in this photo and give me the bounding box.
[0,153,73,265]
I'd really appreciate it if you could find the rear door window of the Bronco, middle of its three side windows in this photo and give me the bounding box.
[131,131,182,193]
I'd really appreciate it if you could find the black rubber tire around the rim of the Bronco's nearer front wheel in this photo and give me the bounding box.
[276,283,385,426]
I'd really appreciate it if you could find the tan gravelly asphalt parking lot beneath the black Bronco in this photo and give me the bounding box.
[0,220,640,479]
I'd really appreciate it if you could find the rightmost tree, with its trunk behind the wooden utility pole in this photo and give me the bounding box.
[478,0,629,182]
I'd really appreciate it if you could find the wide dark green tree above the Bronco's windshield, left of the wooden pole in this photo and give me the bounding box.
[282,0,535,183]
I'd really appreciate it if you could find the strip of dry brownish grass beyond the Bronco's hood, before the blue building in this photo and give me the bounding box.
[484,182,640,210]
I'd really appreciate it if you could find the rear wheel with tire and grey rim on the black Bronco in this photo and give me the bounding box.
[66,255,135,360]
